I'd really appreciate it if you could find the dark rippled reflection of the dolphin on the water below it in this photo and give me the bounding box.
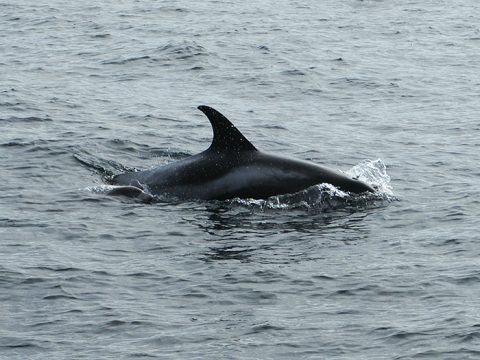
[192,195,375,263]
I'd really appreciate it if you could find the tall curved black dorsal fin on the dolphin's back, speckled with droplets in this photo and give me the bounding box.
[198,105,257,151]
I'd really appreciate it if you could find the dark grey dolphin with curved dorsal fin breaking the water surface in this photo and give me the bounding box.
[112,105,374,200]
